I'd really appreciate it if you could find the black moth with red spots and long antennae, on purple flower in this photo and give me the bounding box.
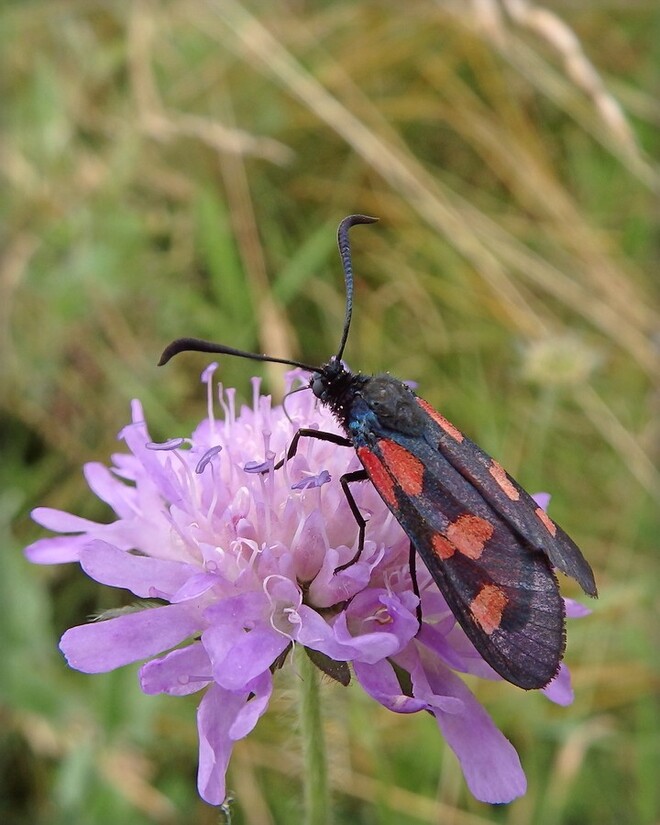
[160,215,597,689]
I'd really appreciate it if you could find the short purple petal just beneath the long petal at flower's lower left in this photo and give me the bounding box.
[139,642,213,696]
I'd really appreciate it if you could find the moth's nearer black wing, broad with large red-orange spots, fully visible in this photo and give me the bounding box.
[357,430,565,689]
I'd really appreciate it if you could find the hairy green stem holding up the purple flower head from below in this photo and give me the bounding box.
[298,646,331,825]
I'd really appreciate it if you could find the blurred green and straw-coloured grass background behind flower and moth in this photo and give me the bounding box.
[0,0,660,825]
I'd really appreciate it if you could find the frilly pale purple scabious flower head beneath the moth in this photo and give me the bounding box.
[26,365,579,804]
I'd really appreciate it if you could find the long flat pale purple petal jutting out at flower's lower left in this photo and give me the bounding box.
[60,604,200,673]
